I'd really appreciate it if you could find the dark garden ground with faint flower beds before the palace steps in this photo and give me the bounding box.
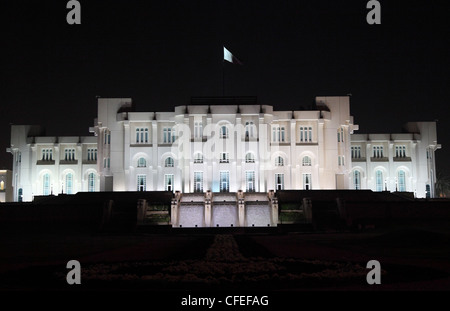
[0,227,450,310]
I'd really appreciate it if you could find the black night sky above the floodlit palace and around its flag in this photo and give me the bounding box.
[0,0,450,175]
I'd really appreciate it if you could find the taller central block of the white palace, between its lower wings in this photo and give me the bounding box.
[92,97,357,193]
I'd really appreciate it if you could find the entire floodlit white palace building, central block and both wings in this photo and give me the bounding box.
[9,97,440,201]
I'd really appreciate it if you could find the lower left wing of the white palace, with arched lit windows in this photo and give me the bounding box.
[8,125,100,202]
